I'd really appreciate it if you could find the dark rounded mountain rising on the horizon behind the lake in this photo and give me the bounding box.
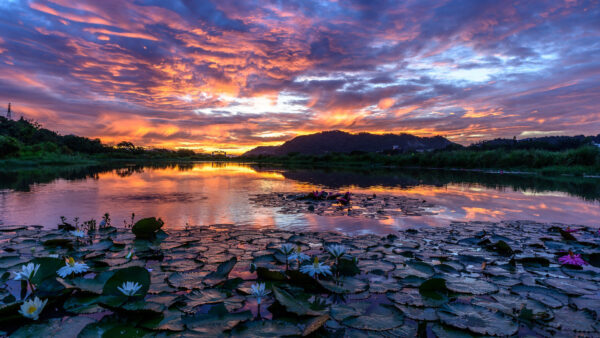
[242,130,456,156]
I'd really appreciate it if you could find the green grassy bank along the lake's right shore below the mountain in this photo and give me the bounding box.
[238,146,600,176]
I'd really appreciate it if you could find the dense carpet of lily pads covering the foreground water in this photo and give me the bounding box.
[0,221,600,337]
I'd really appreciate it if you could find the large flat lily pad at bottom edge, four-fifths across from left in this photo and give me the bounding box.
[438,303,519,336]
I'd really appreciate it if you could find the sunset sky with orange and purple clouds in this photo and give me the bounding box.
[0,0,600,154]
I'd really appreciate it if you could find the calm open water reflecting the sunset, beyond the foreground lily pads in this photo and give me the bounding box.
[0,163,600,234]
